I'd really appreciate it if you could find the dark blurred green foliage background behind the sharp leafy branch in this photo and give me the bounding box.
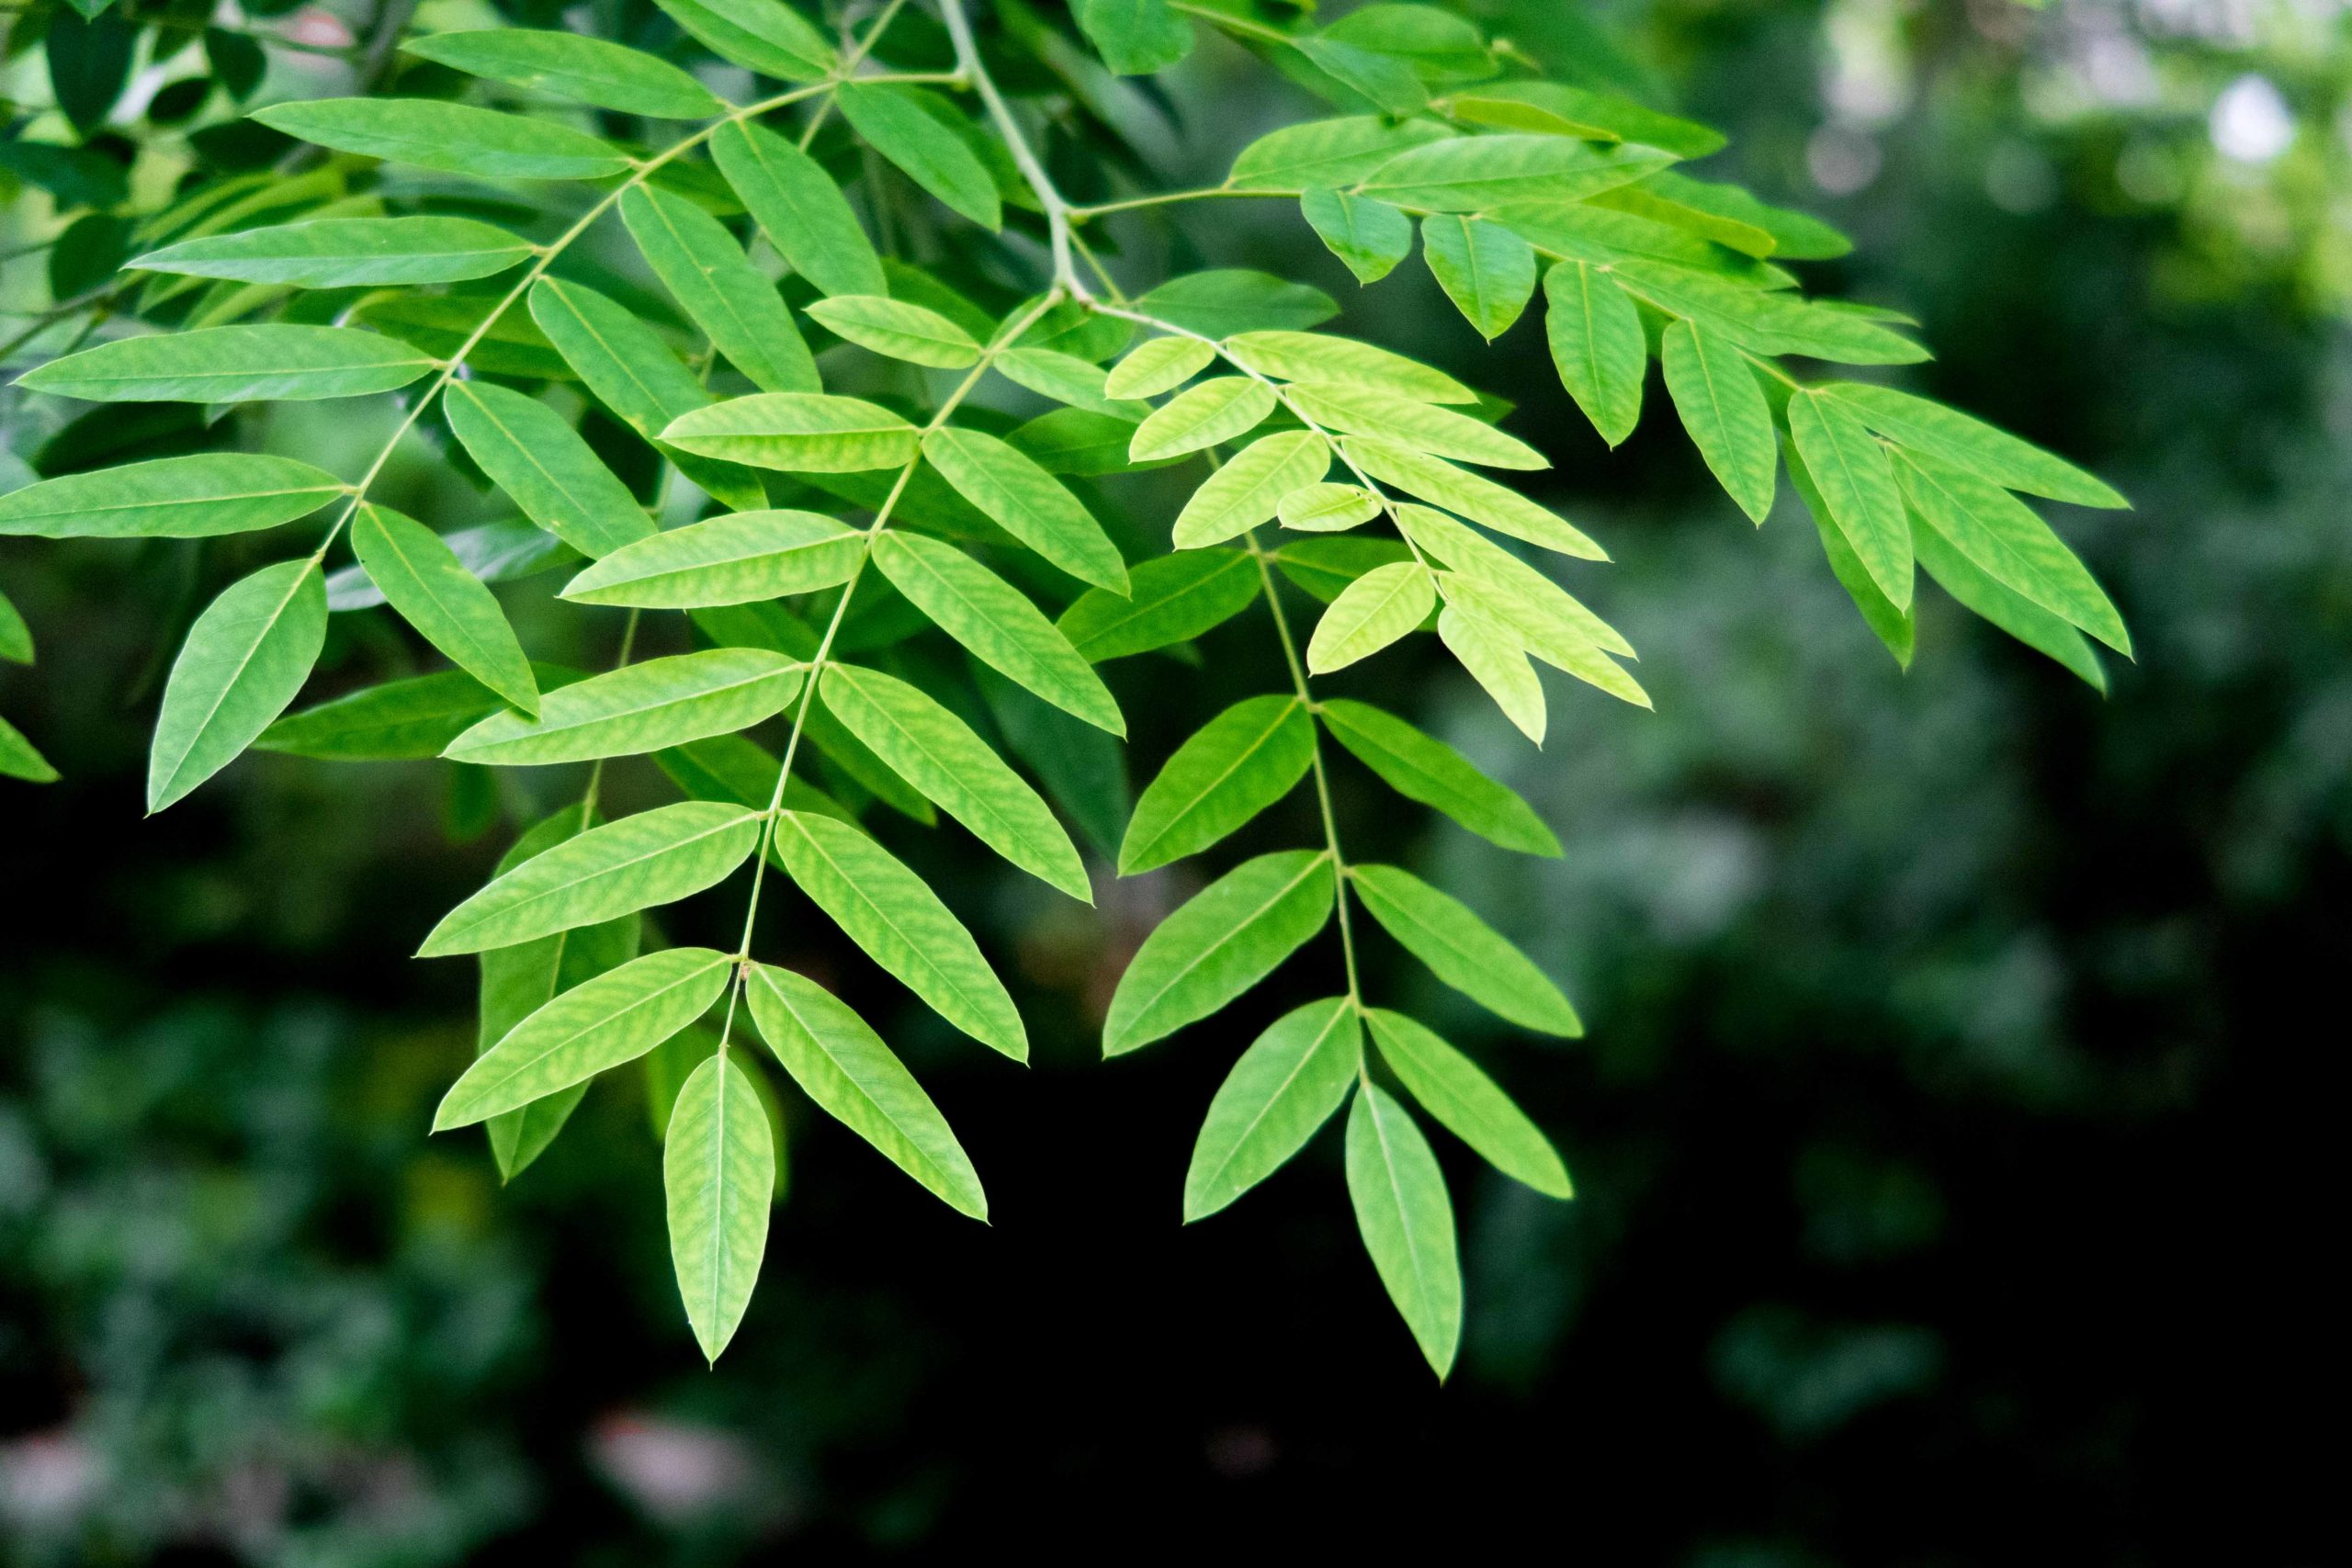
[0,0,2352,1568]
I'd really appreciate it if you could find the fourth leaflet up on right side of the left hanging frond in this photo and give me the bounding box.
[875,531,1126,736]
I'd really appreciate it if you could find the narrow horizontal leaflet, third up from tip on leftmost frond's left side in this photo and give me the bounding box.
[125,219,532,289]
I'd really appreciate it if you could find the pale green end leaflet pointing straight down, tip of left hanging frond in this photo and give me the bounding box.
[661,1051,776,1361]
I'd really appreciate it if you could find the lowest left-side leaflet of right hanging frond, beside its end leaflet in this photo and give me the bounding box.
[1183,997,1364,1224]
